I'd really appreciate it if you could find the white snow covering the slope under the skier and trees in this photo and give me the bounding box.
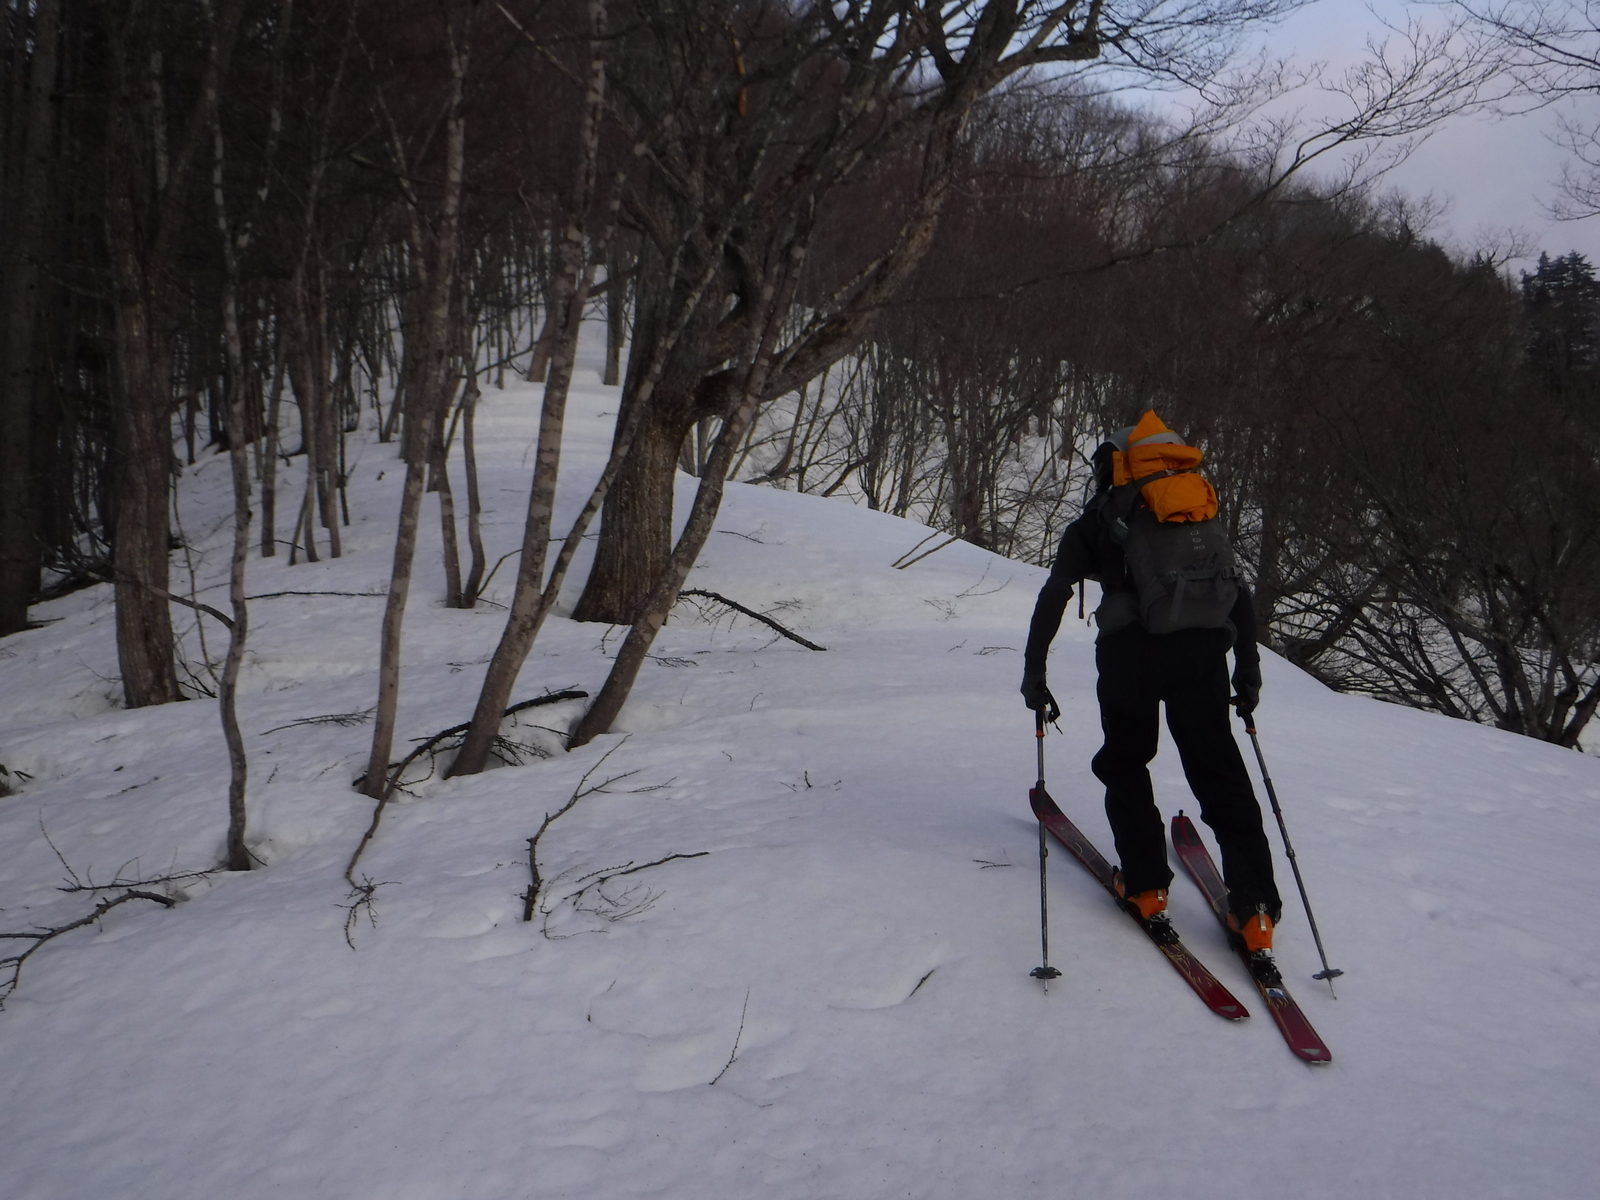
[0,340,1600,1200]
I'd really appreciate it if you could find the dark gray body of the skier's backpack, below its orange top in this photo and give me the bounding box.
[1096,478,1238,634]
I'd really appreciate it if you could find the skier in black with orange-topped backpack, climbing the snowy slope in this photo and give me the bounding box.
[1022,413,1283,968]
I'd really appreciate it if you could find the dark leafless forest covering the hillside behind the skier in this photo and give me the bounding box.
[0,0,1600,867]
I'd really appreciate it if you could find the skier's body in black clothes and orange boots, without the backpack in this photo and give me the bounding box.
[1022,430,1283,952]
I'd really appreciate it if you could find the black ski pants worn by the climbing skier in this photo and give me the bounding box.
[1093,626,1282,917]
